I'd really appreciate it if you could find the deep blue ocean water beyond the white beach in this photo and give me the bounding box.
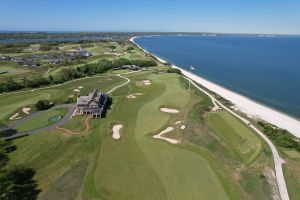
[135,35,300,119]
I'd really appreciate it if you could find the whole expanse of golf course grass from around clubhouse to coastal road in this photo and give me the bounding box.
[0,71,269,200]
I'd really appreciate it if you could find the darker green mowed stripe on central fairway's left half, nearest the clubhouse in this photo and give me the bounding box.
[94,73,166,200]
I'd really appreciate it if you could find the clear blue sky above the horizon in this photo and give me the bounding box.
[0,0,300,34]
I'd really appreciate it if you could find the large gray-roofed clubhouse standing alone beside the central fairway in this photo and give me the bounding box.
[77,90,109,118]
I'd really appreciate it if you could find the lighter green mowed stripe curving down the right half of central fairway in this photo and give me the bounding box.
[135,75,228,200]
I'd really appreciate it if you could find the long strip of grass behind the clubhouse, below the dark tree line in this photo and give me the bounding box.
[0,75,126,121]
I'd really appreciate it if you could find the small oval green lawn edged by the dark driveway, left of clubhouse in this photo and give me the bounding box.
[15,108,68,132]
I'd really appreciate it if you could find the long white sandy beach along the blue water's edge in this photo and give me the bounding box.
[130,36,300,138]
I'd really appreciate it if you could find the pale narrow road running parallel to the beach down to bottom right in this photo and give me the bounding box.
[185,77,289,200]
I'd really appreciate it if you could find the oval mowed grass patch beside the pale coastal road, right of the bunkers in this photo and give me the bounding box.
[207,111,262,164]
